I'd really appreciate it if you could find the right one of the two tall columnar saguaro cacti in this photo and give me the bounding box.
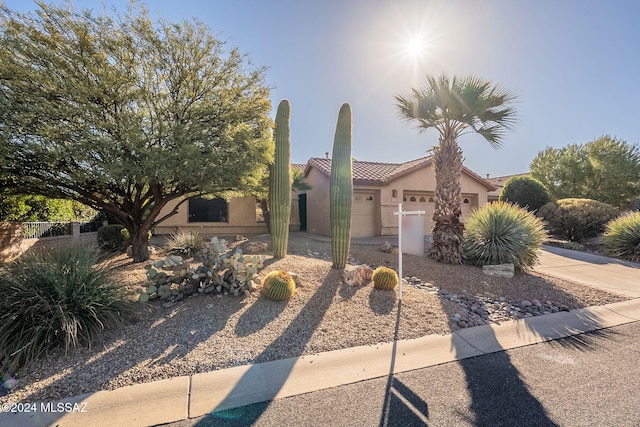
[329,103,353,269]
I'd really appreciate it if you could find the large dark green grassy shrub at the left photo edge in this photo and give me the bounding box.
[0,247,135,367]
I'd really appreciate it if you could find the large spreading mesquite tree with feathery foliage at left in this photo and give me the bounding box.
[0,3,273,261]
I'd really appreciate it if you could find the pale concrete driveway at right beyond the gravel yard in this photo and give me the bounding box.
[534,245,640,298]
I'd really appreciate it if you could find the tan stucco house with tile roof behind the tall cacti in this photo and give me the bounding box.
[154,157,496,237]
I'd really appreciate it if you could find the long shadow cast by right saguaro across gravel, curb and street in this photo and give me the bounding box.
[196,270,341,426]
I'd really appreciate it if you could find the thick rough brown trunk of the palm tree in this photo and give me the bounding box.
[429,136,464,264]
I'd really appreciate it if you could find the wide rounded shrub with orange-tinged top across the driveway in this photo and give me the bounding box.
[536,199,618,242]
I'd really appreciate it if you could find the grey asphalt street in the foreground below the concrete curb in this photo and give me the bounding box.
[166,322,640,427]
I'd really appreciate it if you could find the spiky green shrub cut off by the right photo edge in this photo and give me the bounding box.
[602,212,640,262]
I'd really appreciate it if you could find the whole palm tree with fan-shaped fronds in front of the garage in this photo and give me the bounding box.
[395,74,515,264]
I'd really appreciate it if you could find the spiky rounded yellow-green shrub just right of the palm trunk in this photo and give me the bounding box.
[462,202,546,270]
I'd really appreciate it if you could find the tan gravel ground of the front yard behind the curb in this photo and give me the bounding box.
[0,233,627,403]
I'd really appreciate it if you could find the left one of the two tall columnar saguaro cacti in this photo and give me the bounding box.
[269,99,291,258]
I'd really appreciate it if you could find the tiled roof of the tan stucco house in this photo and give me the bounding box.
[304,157,496,191]
